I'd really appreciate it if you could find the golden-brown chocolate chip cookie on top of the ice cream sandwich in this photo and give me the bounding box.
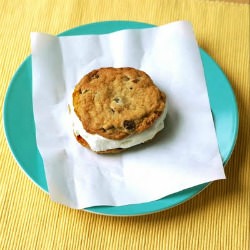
[73,67,166,140]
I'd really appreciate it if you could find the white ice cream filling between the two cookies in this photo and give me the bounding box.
[70,104,167,152]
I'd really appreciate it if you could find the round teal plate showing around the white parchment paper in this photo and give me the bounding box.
[3,21,238,216]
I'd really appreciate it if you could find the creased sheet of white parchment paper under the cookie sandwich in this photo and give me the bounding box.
[31,21,225,209]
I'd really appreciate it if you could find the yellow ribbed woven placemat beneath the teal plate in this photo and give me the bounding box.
[0,0,250,250]
